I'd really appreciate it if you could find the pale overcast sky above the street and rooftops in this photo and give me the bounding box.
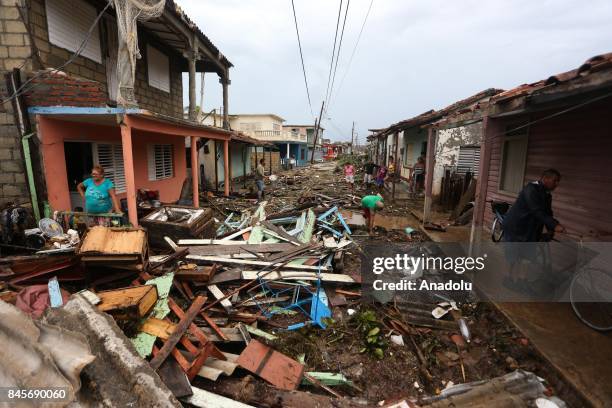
[175,0,612,142]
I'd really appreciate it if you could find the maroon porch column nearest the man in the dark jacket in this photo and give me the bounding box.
[470,116,502,254]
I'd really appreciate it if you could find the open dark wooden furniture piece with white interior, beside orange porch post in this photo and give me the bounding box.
[139,205,215,248]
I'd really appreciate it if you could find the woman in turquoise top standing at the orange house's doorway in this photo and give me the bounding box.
[77,166,121,214]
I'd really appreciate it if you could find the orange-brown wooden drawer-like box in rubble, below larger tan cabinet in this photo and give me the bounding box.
[97,285,157,319]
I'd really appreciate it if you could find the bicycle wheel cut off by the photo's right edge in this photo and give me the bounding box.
[570,268,612,332]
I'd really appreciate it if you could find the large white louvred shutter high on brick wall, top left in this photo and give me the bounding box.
[45,0,102,63]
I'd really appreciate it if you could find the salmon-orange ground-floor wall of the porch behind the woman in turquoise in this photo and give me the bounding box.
[37,116,186,210]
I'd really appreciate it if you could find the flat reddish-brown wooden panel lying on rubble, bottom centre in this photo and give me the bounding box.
[236,340,304,390]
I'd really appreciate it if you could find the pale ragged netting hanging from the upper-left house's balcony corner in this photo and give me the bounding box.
[112,0,166,106]
